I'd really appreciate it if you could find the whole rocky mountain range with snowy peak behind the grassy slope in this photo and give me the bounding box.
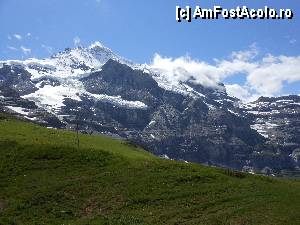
[0,42,300,176]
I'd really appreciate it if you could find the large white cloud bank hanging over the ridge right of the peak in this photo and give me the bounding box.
[150,45,300,101]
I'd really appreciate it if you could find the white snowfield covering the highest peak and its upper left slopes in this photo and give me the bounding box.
[0,42,143,113]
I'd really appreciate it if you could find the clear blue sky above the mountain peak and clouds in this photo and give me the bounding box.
[0,0,300,100]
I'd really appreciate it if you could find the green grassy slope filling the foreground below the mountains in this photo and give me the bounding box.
[0,114,300,225]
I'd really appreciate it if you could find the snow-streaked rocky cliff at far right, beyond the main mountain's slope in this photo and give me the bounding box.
[243,95,300,175]
